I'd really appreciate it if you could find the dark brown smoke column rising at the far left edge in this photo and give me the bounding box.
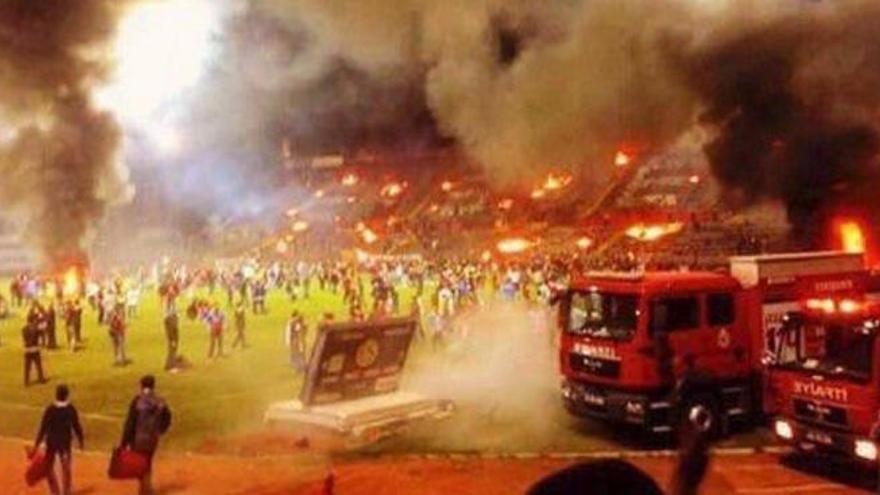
[0,0,131,264]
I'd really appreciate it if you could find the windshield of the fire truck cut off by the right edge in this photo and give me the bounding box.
[787,322,877,380]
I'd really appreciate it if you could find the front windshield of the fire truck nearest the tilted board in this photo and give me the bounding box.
[568,291,639,340]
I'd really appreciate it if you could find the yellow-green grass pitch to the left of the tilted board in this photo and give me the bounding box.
[0,284,410,456]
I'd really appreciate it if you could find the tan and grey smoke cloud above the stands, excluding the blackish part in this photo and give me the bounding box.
[195,0,692,190]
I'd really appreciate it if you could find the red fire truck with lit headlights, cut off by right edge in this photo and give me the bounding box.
[767,286,880,466]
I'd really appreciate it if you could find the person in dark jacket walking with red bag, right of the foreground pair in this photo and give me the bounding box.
[120,375,171,495]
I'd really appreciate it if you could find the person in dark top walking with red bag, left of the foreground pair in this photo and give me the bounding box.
[34,385,84,495]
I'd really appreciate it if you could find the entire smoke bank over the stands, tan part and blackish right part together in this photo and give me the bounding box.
[208,0,880,238]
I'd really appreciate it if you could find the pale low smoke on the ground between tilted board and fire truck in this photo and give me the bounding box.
[405,304,571,451]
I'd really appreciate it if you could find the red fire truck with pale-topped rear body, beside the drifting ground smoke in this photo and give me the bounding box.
[559,252,865,434]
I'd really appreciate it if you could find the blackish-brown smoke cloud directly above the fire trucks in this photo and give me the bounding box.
[682,2,880,247]
